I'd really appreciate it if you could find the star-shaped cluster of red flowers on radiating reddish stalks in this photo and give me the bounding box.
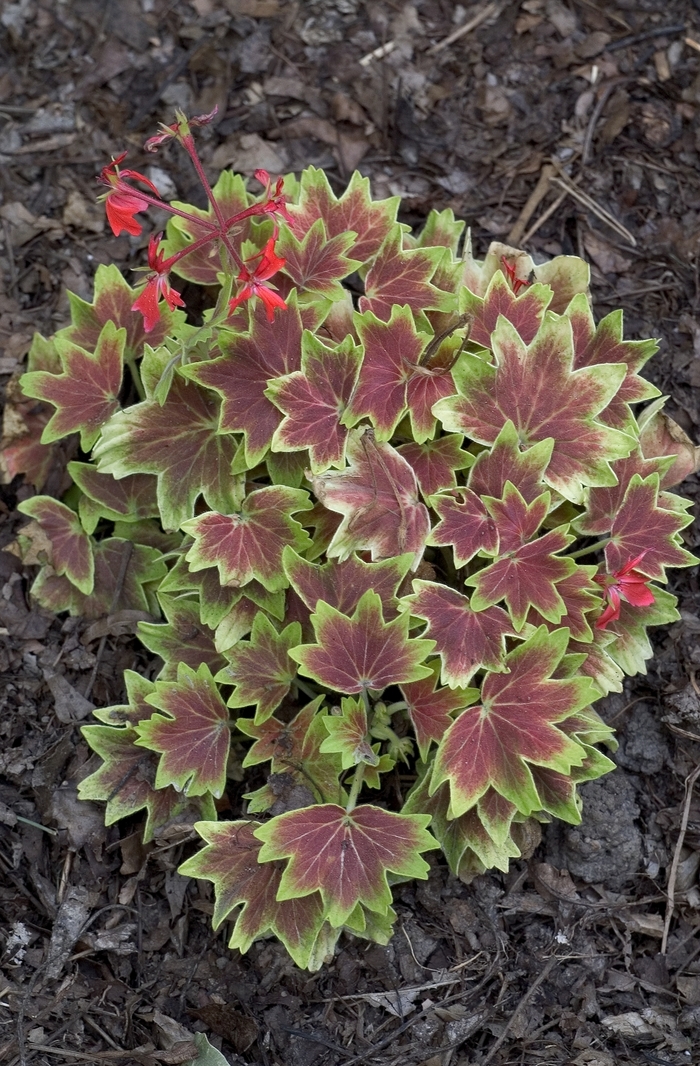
[98,109,293,333]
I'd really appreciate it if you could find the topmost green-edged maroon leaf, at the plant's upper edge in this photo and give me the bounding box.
[289,166,401,262]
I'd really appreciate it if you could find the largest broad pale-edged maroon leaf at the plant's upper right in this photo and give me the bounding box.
[434,314,633,503]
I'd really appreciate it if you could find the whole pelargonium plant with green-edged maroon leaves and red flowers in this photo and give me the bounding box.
[4,114,693,968]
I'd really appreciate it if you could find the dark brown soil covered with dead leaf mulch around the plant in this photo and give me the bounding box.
[0,0,700,1066]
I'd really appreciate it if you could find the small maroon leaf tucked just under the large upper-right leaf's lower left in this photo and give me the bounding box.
[469,419,554,503]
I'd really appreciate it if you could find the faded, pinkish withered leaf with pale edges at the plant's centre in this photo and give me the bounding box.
[312,429,430,564]
